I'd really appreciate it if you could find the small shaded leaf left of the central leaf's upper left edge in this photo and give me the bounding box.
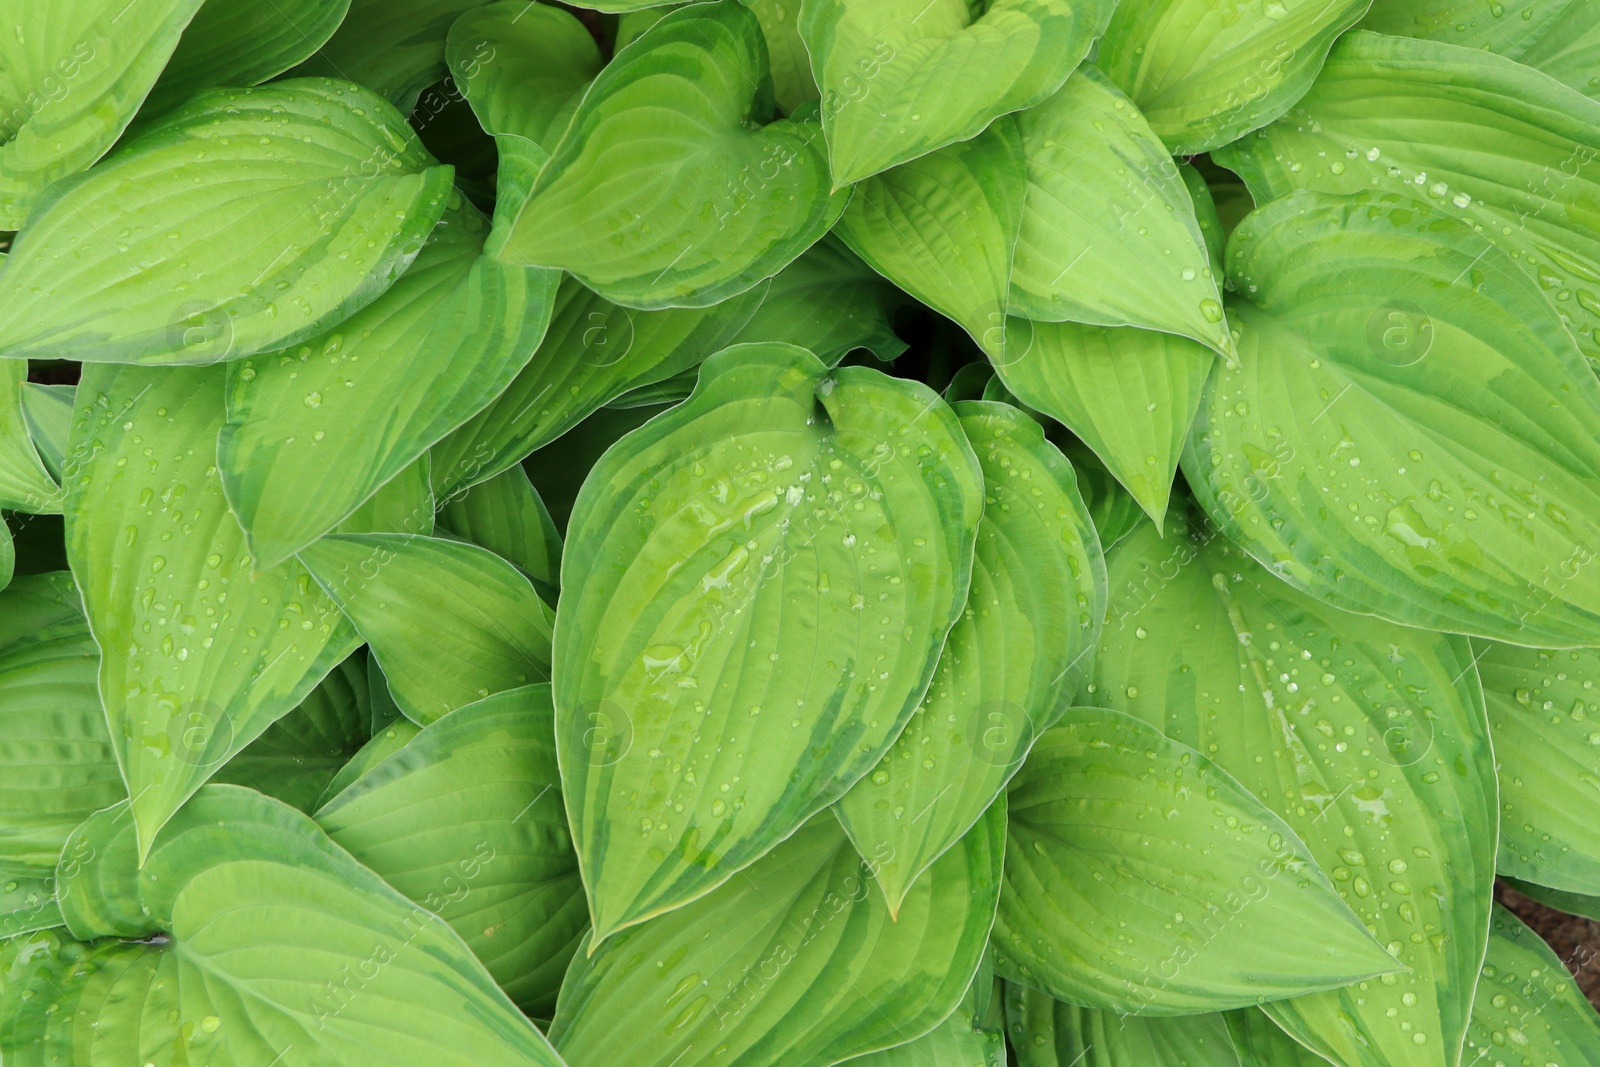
[438,467,562,603]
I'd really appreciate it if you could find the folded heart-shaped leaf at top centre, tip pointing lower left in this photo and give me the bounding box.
[506,0,848,309]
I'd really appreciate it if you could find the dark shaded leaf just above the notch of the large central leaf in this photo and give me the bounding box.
[730,235,910,366]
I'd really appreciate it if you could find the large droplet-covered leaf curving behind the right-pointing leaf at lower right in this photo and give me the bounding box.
[1096,525,1498,1067]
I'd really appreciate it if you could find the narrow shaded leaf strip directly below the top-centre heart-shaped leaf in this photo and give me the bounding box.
[434,278,765,498]
